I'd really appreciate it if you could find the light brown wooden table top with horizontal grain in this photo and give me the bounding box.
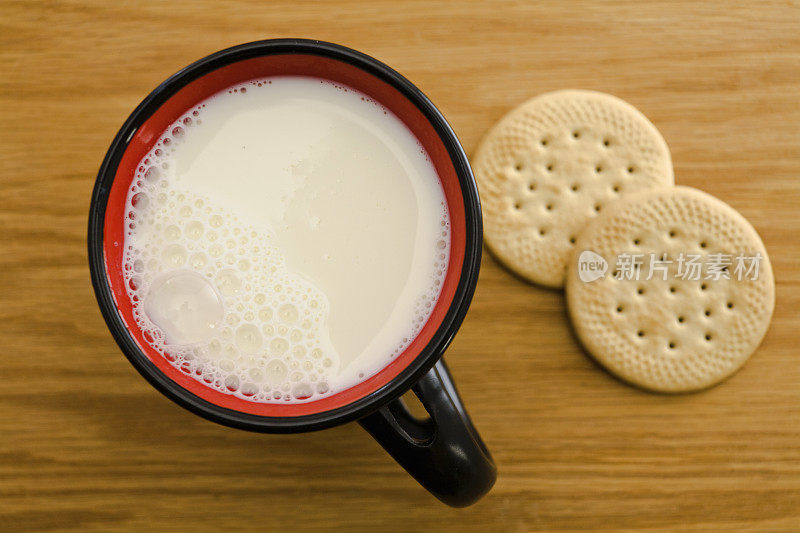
[0,0,800,531]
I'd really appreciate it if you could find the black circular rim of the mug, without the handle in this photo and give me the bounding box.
[88,39,483,433]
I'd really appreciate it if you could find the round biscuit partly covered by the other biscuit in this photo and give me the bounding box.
[473,90,674,288]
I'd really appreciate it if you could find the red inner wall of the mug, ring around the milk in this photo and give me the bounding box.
[103,53,467,417]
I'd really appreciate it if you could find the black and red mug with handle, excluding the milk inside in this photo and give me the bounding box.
[88,39,497,507]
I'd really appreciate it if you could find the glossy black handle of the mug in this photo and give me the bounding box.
[359,359,497,507]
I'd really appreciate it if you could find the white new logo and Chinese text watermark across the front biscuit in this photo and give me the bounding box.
[578,250,763,283]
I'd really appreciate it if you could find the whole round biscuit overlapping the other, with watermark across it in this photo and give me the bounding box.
[566,187,775,392]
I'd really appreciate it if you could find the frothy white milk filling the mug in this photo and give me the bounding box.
[125,77,450,402]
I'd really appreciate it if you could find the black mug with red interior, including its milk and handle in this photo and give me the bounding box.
[88,39,496,506]
